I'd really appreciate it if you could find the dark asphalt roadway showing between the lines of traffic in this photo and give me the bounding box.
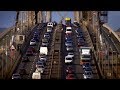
[10,22,99,79]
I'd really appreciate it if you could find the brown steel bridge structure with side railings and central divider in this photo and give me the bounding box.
[0,11,120,79]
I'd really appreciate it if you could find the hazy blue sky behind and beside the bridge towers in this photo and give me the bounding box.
[0,11,120,31]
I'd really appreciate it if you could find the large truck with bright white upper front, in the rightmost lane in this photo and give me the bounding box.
[79,47,92,63]
